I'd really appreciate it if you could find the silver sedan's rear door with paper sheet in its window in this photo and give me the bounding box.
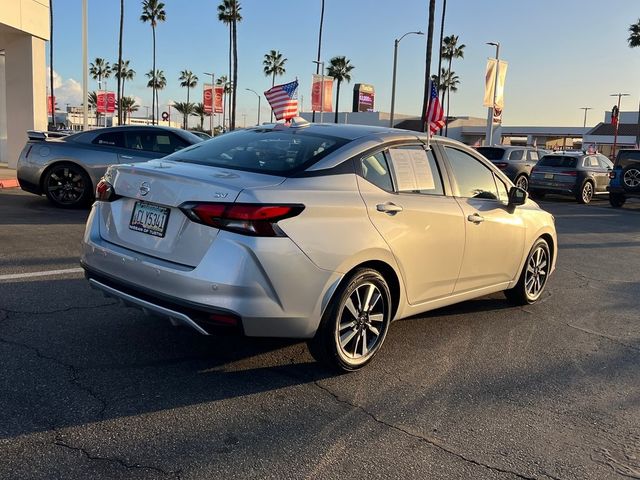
[357,145,465,304]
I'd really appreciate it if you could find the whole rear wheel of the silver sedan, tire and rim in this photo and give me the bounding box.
[307,268,392,372]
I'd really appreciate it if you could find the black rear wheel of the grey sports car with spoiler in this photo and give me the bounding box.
[42,162,93,208]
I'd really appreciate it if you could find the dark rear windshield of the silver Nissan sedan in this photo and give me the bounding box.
[165,129,347,175]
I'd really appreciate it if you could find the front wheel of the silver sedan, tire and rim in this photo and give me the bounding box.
[504,238,551,305]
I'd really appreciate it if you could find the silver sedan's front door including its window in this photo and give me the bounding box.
[443,146,525,293]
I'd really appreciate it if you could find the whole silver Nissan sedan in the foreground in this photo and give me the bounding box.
[81,122,557,370]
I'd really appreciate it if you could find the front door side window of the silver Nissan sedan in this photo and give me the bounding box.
[445,147,499,200]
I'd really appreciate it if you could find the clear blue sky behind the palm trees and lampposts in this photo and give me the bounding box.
[54,0,640,126]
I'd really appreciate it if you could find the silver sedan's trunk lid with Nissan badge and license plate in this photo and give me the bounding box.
[98,160,284,267]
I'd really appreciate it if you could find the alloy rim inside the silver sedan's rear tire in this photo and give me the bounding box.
[335,282,388,361]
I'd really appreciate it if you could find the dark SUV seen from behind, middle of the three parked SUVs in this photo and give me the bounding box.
[529,151,613,203]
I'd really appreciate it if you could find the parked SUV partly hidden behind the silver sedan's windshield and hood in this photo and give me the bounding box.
[476,145,542,190]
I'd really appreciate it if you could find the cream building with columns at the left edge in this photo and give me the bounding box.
[0,0,49,168]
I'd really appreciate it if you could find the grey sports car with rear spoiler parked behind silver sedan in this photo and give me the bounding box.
[17,126,202,208]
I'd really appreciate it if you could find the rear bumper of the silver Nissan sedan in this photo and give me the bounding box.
[81,206,342,338]
